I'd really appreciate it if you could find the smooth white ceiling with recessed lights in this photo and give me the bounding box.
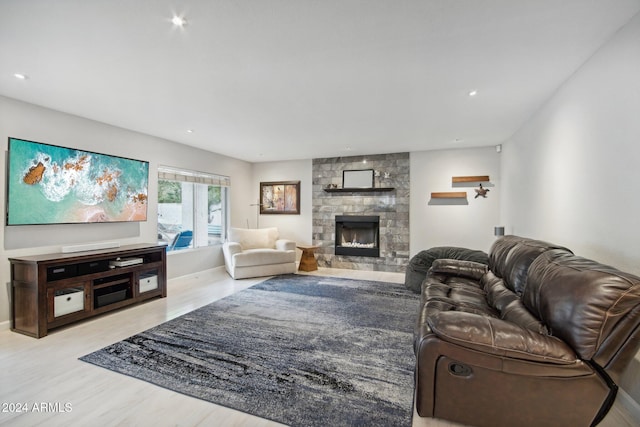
[0,0,640,162]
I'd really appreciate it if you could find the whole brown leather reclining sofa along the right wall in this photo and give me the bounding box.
[414,236,640,427]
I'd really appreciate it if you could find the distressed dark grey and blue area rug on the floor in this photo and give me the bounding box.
[80,274,419,427]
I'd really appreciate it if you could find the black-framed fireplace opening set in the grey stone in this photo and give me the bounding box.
[335,215,380,257]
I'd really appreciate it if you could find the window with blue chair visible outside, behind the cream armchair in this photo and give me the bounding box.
[158,166,230,251]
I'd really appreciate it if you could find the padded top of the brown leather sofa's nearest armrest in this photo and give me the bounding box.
[426,310,578,364]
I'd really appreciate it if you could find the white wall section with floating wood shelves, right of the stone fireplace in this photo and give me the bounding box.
[410,147,502,256]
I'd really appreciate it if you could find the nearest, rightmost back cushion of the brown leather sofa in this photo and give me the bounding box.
[522,250,640,368]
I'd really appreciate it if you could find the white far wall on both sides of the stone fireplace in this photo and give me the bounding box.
[258,147,502,256]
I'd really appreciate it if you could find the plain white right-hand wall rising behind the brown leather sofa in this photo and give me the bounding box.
[502,10,640,274]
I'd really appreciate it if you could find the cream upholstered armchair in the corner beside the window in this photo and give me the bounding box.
[222,227,296,279]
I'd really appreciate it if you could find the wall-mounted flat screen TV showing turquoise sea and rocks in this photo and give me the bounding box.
[6,138,149,225]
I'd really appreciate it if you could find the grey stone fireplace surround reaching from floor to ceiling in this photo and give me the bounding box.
[312,153,410,273]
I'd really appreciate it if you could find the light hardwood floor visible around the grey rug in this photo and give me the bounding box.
[0,268,637,427]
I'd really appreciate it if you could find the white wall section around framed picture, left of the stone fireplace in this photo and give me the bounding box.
[251,160,313,251]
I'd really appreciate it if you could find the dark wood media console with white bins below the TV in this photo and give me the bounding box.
[9,244,167,338]
